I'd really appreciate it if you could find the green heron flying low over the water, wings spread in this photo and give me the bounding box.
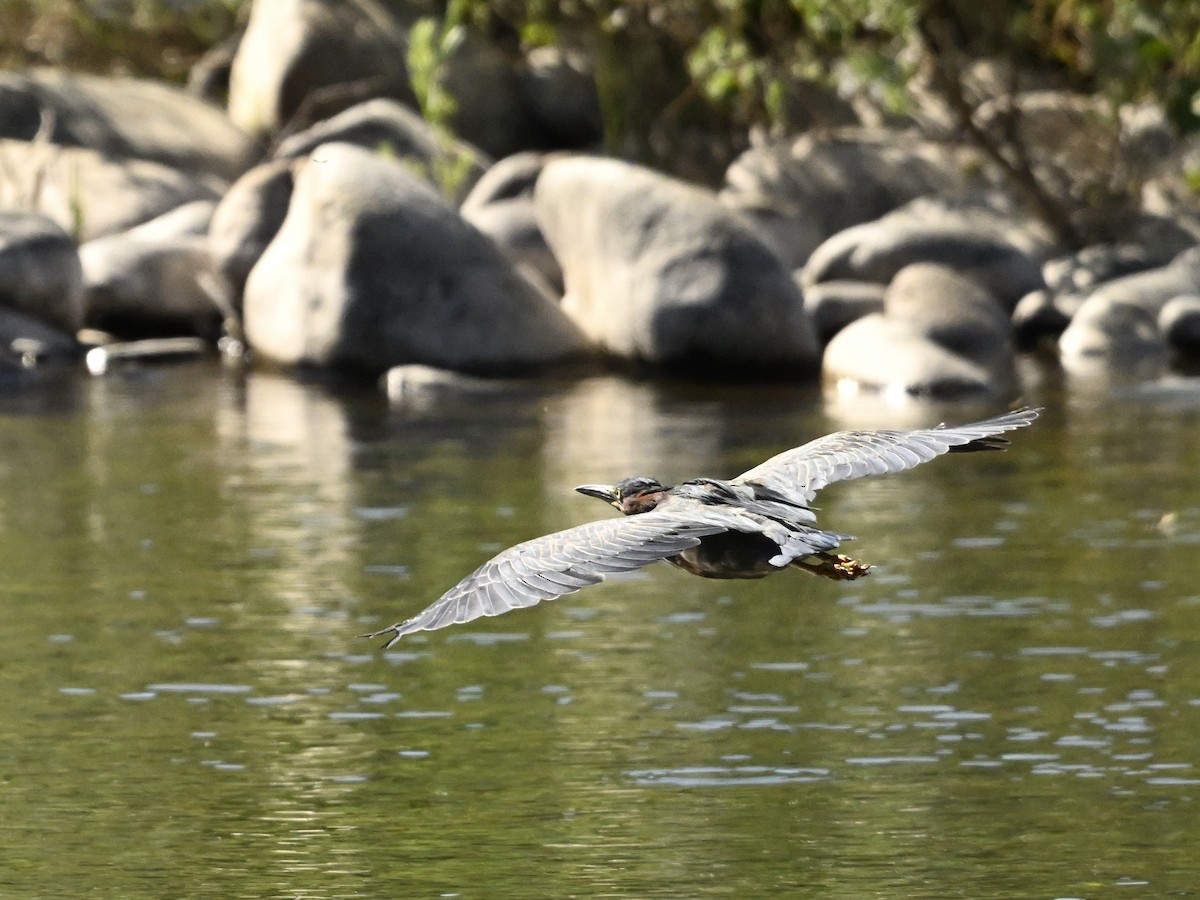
[365,408,1038,649]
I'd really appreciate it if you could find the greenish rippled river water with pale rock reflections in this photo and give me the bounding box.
[0,362,1200,900]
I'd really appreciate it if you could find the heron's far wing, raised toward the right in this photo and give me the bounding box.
[733,407,1038,503]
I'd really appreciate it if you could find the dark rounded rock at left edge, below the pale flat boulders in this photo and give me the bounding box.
[0,210,83,335]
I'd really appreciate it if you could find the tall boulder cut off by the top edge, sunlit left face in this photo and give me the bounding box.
[229,0,414,137]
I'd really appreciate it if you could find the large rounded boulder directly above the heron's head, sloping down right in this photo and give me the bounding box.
[534,157,818,378]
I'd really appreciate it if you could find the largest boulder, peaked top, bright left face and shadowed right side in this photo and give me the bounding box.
[244,144,588,374]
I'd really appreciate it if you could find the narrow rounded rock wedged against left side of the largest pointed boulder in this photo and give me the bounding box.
[209,160,294,308]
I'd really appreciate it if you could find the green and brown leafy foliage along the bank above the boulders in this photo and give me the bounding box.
[0,0,1200,240]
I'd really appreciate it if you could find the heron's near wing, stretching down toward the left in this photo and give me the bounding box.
[366,511,731,649]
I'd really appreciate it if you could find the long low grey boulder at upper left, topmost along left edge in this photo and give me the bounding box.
[0,68,257,182]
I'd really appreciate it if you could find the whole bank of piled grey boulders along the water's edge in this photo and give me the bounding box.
[0,0,1200,400]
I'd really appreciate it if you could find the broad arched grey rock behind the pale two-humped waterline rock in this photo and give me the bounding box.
[802,202,1044,310]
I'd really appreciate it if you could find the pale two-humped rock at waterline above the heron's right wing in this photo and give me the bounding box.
[823,264,1016,398]
